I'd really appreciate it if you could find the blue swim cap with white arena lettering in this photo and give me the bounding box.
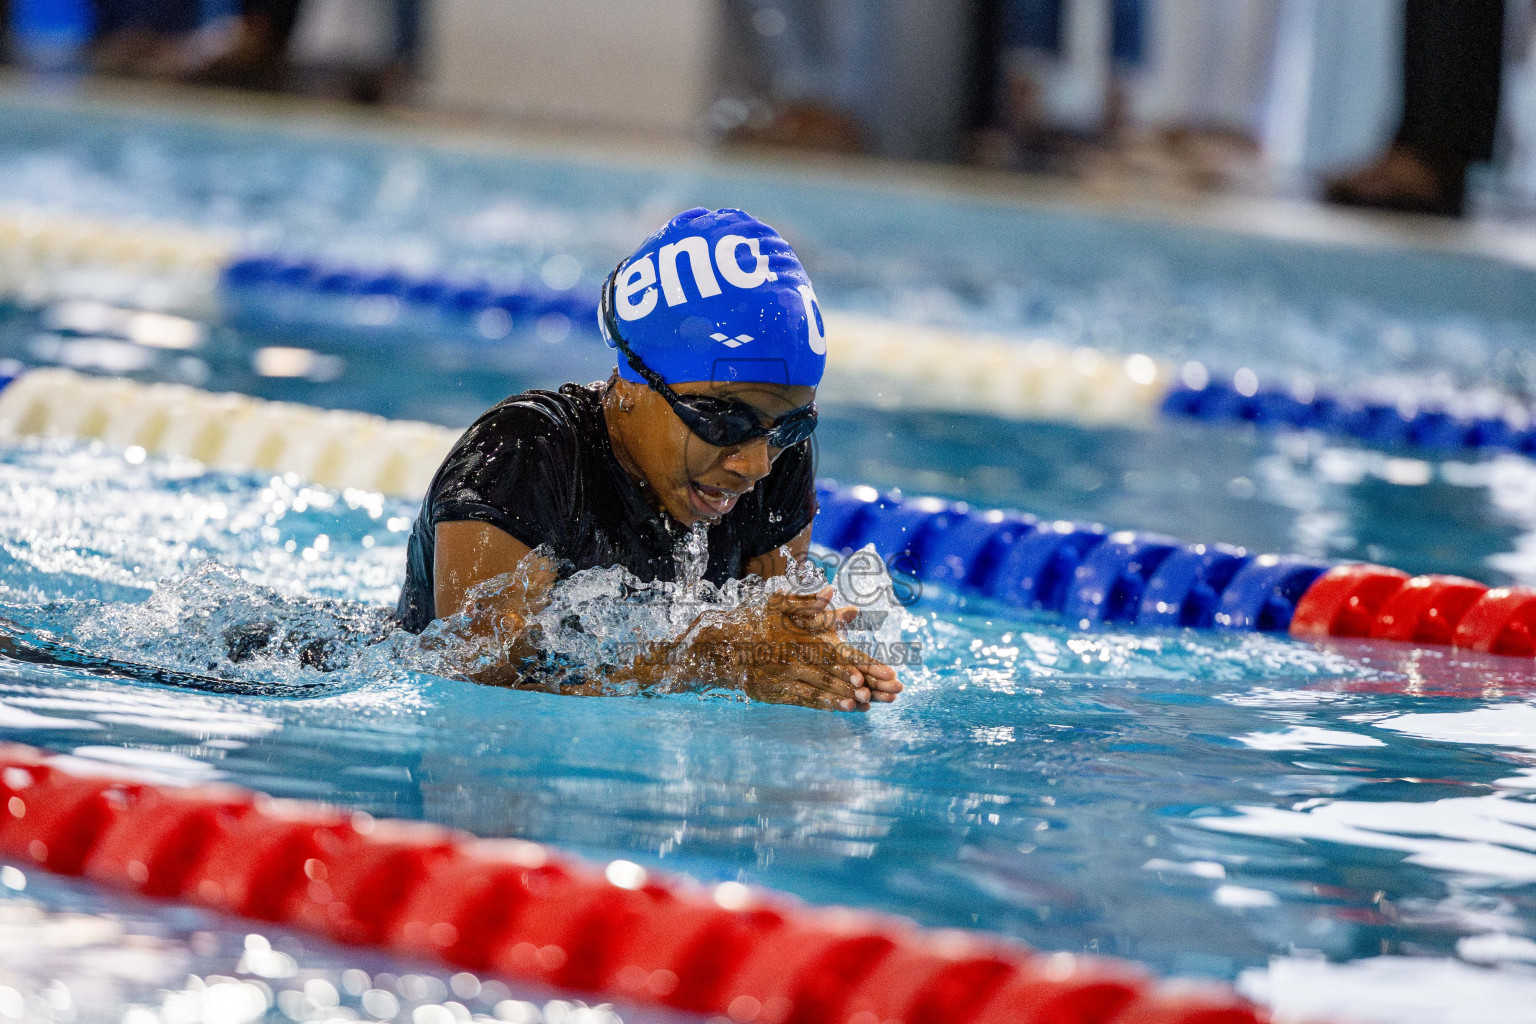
[598,207,826,387]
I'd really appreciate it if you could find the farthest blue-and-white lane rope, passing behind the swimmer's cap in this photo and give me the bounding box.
[0,210,1536,456]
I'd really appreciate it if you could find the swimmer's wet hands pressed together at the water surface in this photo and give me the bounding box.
[693,588,902,711]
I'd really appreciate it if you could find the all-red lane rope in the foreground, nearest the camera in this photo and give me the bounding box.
[0,745,1267,1024]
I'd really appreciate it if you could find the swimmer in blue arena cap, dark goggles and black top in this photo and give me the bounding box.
[396,209,902,711]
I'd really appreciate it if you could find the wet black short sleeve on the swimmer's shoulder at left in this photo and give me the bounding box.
[430,402,578,551]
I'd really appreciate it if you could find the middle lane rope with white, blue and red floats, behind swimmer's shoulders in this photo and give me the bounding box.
[0,368,1536,657]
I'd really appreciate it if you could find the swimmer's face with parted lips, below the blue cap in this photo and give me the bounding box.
[617,381,816,527]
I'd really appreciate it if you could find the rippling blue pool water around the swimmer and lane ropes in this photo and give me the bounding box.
[0,92,1536,1024]
